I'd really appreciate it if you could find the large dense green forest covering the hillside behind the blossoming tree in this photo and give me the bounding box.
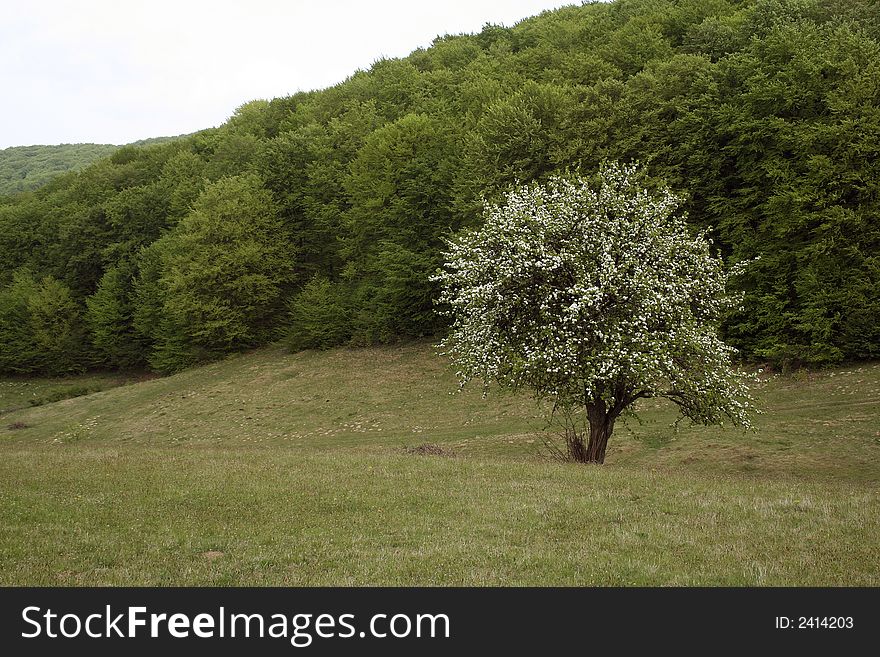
[0,0,880,373]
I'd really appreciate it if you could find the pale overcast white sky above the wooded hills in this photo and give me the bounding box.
[0,0,579,148]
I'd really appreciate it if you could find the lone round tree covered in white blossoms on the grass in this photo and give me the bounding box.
[435,164,751,463]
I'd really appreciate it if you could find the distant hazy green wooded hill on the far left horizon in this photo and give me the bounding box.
[0,137,176,194]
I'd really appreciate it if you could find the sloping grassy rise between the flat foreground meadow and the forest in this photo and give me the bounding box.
[6,343,880,485]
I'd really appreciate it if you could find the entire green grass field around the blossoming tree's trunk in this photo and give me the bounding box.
[0,344,880,586]
